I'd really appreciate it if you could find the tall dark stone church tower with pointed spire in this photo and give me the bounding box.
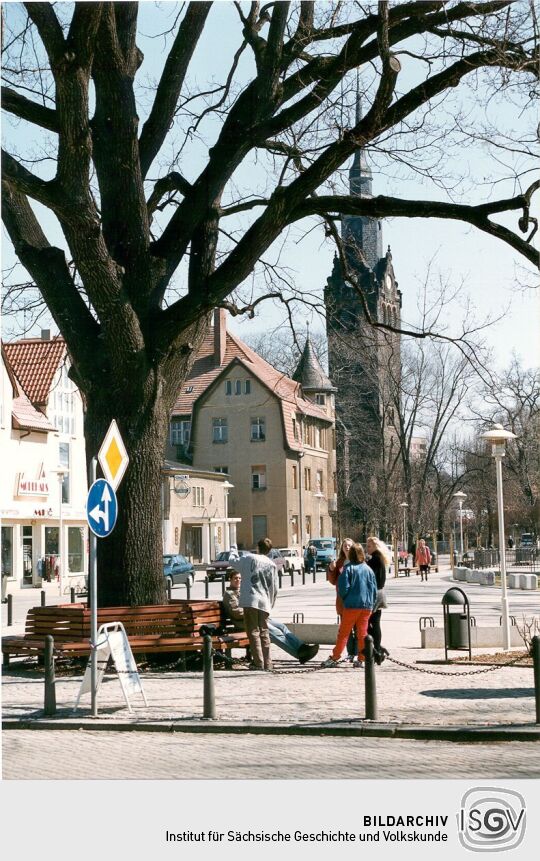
[325,102,401,539]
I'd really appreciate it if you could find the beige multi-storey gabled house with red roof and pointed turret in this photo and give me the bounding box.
[168,310,335,548]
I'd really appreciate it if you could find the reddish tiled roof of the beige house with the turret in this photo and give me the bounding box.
[173,329,331,450]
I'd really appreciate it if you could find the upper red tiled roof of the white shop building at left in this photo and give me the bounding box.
[4,336,66,406]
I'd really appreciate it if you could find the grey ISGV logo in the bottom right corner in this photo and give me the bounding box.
[458,786,527,852]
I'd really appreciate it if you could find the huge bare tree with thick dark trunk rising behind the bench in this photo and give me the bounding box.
[2,0,538,604]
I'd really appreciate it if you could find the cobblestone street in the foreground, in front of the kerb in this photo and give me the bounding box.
[3,730,540,780]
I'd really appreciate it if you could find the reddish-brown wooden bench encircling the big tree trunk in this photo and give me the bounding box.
[2,600,249,665]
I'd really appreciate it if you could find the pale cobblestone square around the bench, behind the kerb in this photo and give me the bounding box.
[2,556,540,726]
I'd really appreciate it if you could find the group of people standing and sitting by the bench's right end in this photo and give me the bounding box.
[227,536,390,671]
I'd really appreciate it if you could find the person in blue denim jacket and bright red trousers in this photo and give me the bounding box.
[321,544,377,667]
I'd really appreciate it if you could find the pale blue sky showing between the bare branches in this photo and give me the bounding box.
[3,2,540,367]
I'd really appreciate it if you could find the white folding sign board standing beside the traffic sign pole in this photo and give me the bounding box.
[75,622,148,712]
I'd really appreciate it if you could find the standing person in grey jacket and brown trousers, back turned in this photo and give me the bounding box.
[230,538,278,671]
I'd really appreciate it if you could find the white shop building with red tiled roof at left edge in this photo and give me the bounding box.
[0,332,87,594]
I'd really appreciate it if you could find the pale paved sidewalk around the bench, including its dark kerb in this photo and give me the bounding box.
[3,560,540,741]
